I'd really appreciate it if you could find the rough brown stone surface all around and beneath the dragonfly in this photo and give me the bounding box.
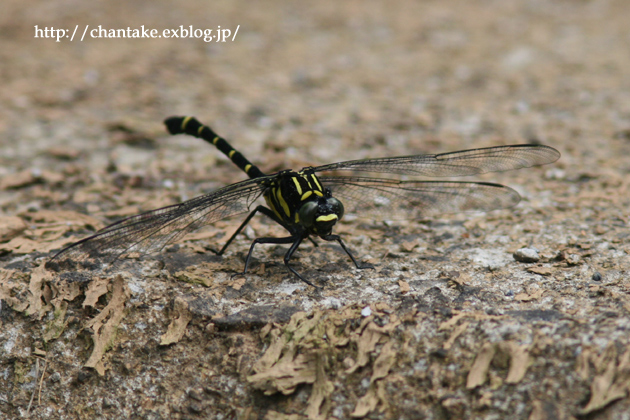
[0,0,630,419]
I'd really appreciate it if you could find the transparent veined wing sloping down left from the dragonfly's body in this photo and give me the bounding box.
[53,177,269,263]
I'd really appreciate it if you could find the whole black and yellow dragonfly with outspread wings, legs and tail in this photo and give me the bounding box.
[53,117,560,286]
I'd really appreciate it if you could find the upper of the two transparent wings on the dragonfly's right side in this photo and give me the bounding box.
[314,144,560,176]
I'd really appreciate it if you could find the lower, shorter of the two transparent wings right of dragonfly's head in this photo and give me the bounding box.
[320,176,521,220]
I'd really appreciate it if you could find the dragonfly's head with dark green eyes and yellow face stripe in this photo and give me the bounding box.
[298,189,343,236]
